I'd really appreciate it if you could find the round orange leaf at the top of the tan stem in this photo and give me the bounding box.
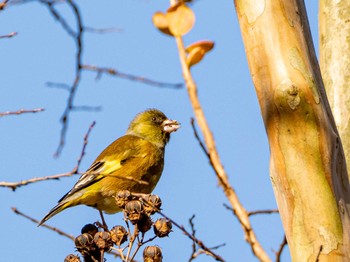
[166,3,195,36]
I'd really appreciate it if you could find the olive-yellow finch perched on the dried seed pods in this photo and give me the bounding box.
[38,108,181,226]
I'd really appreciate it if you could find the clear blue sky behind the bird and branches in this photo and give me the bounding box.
[0,0,318,261]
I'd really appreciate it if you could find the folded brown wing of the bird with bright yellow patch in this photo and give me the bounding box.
[58,135,150,202]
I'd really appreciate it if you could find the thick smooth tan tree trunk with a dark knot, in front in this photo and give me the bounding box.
[235,0,350,262]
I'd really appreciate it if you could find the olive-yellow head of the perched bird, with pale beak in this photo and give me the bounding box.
[126,109,180,147]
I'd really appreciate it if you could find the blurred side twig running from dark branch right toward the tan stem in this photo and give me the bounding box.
[82,65,183,89]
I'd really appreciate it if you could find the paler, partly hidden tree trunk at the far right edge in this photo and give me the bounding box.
[319,0,350,180]
